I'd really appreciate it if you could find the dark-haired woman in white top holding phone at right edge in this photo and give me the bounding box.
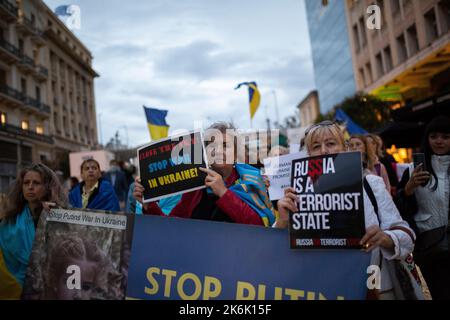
[397,116,450,300]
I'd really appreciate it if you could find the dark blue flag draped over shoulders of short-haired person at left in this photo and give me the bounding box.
[69,179,120,212]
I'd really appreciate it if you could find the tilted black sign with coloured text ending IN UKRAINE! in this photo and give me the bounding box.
[137,131,208,203]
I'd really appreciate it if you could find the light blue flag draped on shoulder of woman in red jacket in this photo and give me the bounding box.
[230,163,275,227]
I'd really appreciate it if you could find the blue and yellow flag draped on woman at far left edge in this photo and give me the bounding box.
[0,205,36,299]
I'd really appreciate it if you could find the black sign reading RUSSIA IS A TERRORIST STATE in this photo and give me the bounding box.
[289,152,365,249]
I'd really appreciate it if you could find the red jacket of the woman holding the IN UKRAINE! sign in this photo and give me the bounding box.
[143,169,264,226]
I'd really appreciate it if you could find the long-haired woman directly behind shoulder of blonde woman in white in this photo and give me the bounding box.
[349,135,391,193]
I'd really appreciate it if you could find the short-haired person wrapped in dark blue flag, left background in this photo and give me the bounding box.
[69,159,120,211]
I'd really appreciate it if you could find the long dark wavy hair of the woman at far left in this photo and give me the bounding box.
[2,164,67,222]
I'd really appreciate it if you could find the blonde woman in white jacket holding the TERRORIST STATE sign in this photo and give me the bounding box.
[274,121,415,299]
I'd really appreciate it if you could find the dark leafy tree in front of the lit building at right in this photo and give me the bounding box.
[316,92,392,132]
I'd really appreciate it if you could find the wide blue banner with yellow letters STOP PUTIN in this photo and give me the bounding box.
[127,216,371,300]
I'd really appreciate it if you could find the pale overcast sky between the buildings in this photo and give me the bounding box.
[45,0,314,146]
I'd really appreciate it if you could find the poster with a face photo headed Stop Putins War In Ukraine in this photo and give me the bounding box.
[23,209,134,300]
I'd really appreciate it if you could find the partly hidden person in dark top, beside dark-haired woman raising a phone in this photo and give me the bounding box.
[365,134,398,195]
